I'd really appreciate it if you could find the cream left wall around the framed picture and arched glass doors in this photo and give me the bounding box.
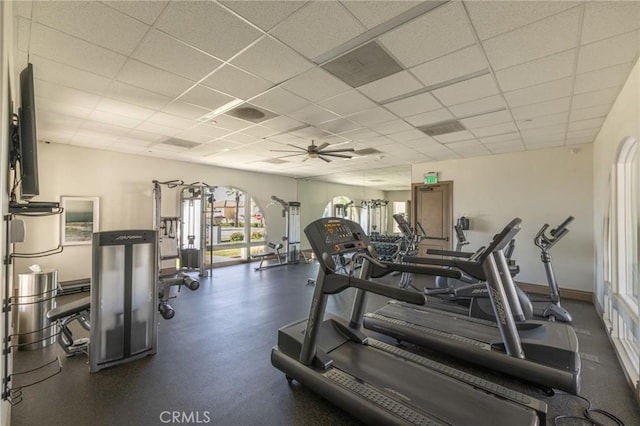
[15,143,296,281]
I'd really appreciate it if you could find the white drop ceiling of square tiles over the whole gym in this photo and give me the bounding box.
[14,1,640,190]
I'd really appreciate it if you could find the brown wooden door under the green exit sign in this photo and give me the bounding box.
[412,182,453,256]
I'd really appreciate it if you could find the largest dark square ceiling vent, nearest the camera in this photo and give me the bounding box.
[322,41,403,87]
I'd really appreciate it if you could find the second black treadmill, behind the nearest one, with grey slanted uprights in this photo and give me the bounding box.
[362,218,580,395]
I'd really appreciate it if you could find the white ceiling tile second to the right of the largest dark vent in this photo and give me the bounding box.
[496,51,575,92]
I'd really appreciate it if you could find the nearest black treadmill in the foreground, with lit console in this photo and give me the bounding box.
[271,218,547,425]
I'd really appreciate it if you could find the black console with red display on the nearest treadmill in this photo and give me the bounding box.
[304,217,369,259]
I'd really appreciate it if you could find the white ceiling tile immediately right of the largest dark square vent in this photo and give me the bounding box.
[410,44,489,87]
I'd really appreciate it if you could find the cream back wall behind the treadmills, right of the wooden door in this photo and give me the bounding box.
[412,144,594,292]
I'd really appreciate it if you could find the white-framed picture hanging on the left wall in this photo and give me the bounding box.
[60,196,100,246]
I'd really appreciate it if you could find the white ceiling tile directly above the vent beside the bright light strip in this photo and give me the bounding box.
[200,65,273,100]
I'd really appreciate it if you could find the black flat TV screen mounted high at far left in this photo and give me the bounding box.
[19,64,40,200]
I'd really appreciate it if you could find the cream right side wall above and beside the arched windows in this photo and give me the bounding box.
[593,62,640,307]
